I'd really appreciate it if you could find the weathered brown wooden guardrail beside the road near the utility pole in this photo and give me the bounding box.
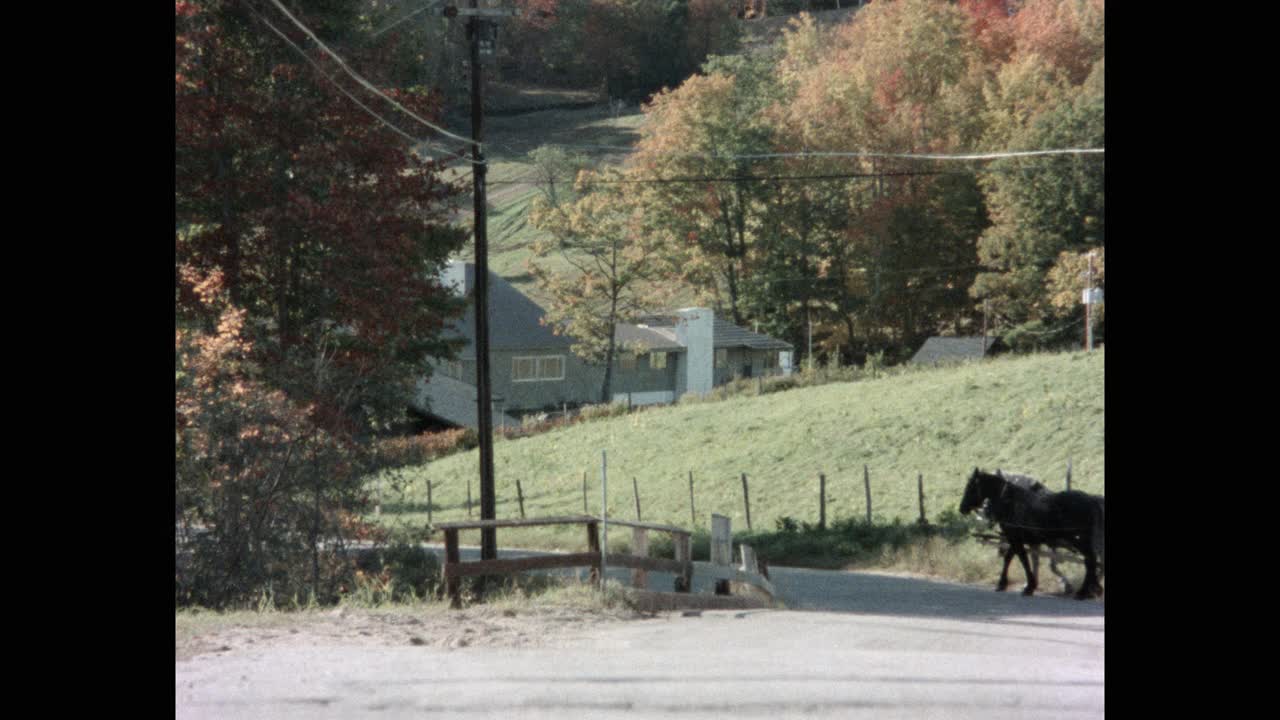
[435,515,694,607]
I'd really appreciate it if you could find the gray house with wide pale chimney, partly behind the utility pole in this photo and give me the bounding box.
[412,261,791,428]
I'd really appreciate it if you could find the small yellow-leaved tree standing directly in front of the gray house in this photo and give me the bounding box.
[530,172,672,402]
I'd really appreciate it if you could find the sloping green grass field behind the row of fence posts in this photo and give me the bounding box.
[371,350,1106,550]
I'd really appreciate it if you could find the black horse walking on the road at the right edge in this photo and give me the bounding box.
[960,468,1105,600]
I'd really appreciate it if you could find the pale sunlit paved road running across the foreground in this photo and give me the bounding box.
[177,545,1105,720]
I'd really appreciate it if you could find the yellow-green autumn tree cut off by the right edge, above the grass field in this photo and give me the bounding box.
[970,0,1106,347]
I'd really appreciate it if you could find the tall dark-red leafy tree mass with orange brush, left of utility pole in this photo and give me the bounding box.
[174,0,462,603]
